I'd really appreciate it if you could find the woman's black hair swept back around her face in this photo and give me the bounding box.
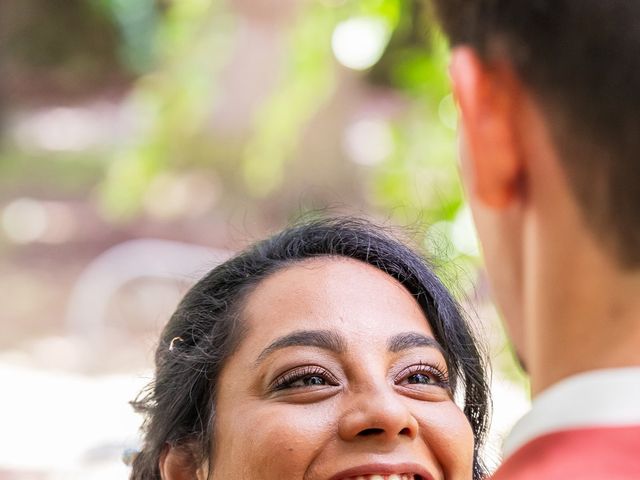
[131,218,490,480]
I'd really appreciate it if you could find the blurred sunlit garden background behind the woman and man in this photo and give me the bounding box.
[0,0,528,480]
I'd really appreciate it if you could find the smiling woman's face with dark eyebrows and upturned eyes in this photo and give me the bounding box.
[212,258,473,480]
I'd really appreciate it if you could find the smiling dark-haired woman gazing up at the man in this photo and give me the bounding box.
[131,219,489,480]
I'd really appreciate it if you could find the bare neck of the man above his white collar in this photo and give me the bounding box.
[526,219,640,396]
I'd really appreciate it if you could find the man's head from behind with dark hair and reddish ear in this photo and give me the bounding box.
[434,0,640,386]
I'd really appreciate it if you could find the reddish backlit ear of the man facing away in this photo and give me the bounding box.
[450,47,524,209]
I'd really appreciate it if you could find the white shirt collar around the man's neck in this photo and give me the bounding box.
[503,367,640,459]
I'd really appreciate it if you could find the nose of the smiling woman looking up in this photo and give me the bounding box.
[338,387,418,441]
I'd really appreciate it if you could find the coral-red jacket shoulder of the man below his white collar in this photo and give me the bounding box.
[492,425,640,480]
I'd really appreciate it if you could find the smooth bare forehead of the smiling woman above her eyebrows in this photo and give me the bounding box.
[242,257,432,343]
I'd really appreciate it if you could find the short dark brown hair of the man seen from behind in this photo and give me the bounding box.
[433,0,640,268]
